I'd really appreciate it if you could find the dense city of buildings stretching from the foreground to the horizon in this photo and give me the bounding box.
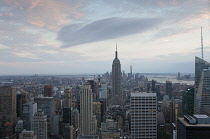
[0,47,210,139]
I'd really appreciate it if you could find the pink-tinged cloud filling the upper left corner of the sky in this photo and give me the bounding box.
[0,0,83,30]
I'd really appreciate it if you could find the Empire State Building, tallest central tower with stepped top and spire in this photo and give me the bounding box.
[112,48,122,105]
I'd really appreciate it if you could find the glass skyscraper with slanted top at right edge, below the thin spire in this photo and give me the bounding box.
[194,57,210,114]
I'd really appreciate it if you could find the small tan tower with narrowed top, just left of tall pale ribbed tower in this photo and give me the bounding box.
[63,87,72,108]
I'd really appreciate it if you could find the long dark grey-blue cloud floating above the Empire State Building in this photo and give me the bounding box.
[58,17,162,47]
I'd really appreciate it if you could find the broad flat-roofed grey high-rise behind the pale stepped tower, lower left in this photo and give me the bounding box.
[34,97,56,136]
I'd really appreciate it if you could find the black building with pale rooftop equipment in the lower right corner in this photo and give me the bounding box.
[177,114,210,139]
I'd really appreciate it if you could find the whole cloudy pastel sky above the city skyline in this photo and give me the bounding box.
[0,0,210,75]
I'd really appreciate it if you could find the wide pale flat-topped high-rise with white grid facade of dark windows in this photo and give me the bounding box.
[130,92,157,139]
